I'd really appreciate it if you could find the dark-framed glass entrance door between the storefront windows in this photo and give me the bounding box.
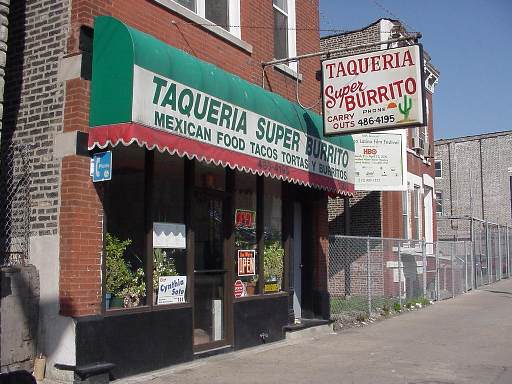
[192,191,227,350]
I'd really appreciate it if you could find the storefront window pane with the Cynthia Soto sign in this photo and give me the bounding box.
[151,152,188,305]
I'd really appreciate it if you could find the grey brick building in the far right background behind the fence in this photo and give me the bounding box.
[435,131,512,239]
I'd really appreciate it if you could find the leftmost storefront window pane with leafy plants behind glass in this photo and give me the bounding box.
[104,146,147,309]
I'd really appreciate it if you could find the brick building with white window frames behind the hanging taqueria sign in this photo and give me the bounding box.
[320,19,439,296]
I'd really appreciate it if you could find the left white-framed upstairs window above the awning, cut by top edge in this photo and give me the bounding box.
[172,0,241,38]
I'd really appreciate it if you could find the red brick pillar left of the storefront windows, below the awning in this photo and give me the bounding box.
[59,156,103,316]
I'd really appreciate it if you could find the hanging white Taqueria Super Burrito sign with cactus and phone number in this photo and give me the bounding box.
[322,44,426,135]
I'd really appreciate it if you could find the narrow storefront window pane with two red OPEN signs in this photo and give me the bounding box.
[233,172,259,296]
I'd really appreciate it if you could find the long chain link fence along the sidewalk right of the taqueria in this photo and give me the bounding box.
[328,228,512,322]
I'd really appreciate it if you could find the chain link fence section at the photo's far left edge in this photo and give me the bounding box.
[0,145,31,266]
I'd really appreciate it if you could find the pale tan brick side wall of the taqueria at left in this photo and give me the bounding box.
[2,0,69,236]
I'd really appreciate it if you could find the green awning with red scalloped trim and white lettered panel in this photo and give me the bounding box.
[89,16,354,194]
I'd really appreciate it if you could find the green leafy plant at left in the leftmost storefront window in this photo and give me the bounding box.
[105,233,133,296]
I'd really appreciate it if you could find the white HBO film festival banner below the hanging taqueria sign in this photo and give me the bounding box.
[352,129,407,191]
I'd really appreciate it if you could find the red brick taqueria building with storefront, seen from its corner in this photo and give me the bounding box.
[2,0,353,382]
